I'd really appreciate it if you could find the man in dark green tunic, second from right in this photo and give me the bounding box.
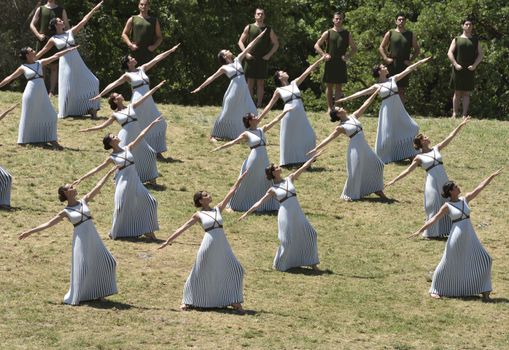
[378,12,420,102]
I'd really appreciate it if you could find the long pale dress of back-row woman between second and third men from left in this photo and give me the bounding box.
[211,58,258,140]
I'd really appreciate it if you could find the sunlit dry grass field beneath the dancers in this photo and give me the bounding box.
[0,92,509,349]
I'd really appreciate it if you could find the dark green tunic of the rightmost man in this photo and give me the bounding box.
[451,36,479,91]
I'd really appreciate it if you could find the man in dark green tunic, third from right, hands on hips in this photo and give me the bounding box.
[315,12,357,112]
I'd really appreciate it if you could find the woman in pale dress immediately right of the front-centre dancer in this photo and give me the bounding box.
[239,152,321,271]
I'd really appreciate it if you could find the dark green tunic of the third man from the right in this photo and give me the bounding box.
[323,29,350,84]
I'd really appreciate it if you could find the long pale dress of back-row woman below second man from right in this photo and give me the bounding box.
[375,77,419,164]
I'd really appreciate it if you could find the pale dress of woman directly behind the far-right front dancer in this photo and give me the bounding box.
[416,146,452,238]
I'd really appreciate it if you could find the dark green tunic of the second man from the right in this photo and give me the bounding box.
[387,29,413,87]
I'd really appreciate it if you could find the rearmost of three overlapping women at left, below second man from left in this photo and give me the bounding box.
[92,44,180,159]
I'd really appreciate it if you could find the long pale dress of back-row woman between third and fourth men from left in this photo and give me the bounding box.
[277,80,316,166]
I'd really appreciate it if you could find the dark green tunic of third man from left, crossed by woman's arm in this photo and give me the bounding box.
[244,24,272,79]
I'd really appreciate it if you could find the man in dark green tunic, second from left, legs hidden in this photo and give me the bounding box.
[122,0,163,65]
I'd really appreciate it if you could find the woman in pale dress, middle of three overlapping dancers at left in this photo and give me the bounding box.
[80,81,165,184]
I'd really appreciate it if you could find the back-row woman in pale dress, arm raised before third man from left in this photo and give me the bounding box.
[191,30,265,141]
